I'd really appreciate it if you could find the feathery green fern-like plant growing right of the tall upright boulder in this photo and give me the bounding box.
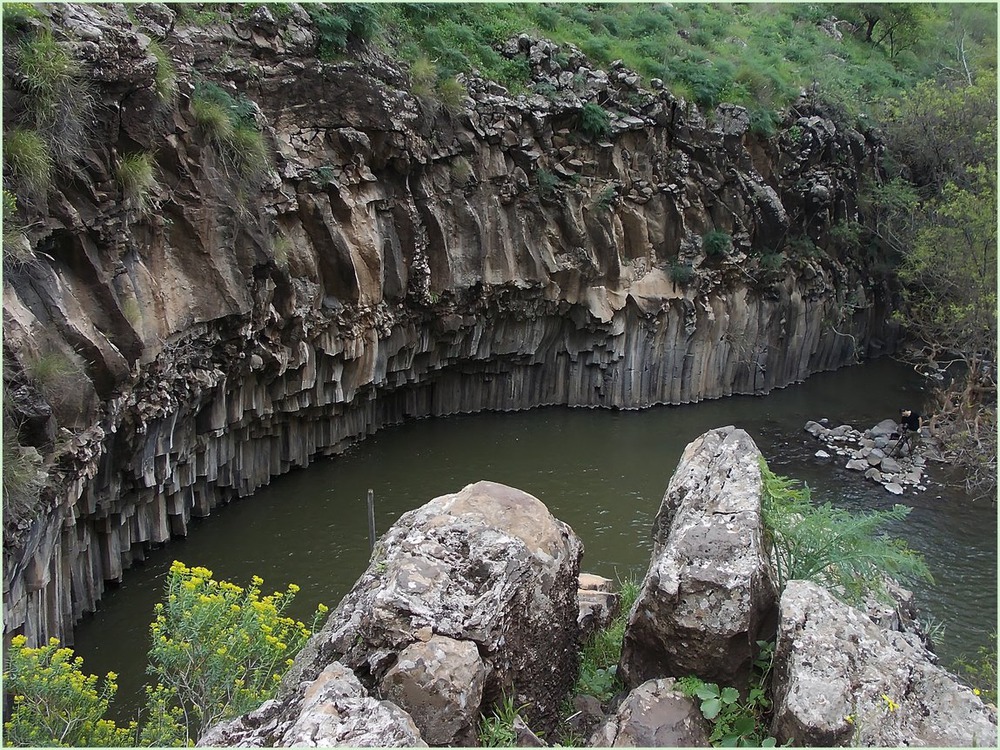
[760,459,934,604]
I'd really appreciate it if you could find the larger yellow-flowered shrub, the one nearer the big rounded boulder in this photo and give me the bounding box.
[147,561,327,730]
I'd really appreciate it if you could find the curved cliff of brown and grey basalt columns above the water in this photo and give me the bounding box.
[4,4,896,642]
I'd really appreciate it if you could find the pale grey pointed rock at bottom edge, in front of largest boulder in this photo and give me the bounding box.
[198,662,427,747]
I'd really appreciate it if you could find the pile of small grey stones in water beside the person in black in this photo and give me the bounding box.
[804,419,933,495]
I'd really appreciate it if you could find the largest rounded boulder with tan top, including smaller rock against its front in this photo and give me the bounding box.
[286,482,582,744]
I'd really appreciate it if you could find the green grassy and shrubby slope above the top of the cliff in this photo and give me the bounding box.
[278,3,997,134]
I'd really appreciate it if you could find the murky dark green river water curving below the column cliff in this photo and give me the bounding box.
[76,361,997,714]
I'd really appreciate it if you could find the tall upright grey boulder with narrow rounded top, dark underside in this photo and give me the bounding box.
[620,427,775,686]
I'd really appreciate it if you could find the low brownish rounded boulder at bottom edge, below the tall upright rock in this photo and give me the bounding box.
[588,678,712,747]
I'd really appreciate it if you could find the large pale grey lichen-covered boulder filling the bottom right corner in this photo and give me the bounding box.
[771,581,997,747]
